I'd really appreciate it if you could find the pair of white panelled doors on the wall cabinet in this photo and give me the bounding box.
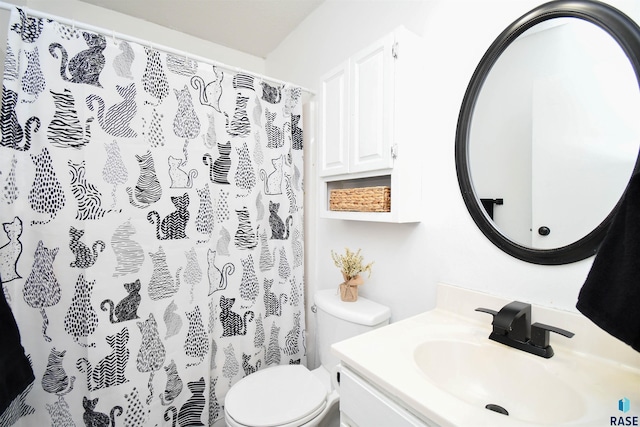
[320,34,395,176]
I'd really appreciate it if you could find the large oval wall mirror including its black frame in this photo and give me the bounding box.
[455,0,640,265]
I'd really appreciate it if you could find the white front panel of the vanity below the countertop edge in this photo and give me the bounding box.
[340,367,436,427]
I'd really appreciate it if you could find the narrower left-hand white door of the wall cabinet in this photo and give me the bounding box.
[319,62,349,176]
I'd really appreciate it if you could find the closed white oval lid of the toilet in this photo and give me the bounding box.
[224,365,327,427]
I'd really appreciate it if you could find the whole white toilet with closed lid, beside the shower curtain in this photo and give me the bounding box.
[224,289,391,427]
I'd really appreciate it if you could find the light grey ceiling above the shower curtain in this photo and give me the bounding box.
[81,0,324,58]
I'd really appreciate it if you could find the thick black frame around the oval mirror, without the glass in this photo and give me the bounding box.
[455,0,640,265]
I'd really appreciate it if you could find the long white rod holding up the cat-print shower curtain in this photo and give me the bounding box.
[0,1,316,96]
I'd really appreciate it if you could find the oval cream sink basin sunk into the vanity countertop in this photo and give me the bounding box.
[413,337,587,425]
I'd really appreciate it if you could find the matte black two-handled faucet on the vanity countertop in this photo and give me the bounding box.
[476,301,574,359]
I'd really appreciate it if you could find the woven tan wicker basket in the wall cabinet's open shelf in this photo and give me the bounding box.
[329,186,391,212]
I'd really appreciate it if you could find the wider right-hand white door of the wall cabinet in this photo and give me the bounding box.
[349,35,394,172]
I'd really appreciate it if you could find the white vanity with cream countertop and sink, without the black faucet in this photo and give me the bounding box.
[332,284,640,427]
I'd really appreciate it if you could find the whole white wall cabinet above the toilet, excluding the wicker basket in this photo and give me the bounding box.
[318,28,426,222]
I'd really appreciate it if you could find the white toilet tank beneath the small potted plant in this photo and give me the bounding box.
[314,289,391,372]
